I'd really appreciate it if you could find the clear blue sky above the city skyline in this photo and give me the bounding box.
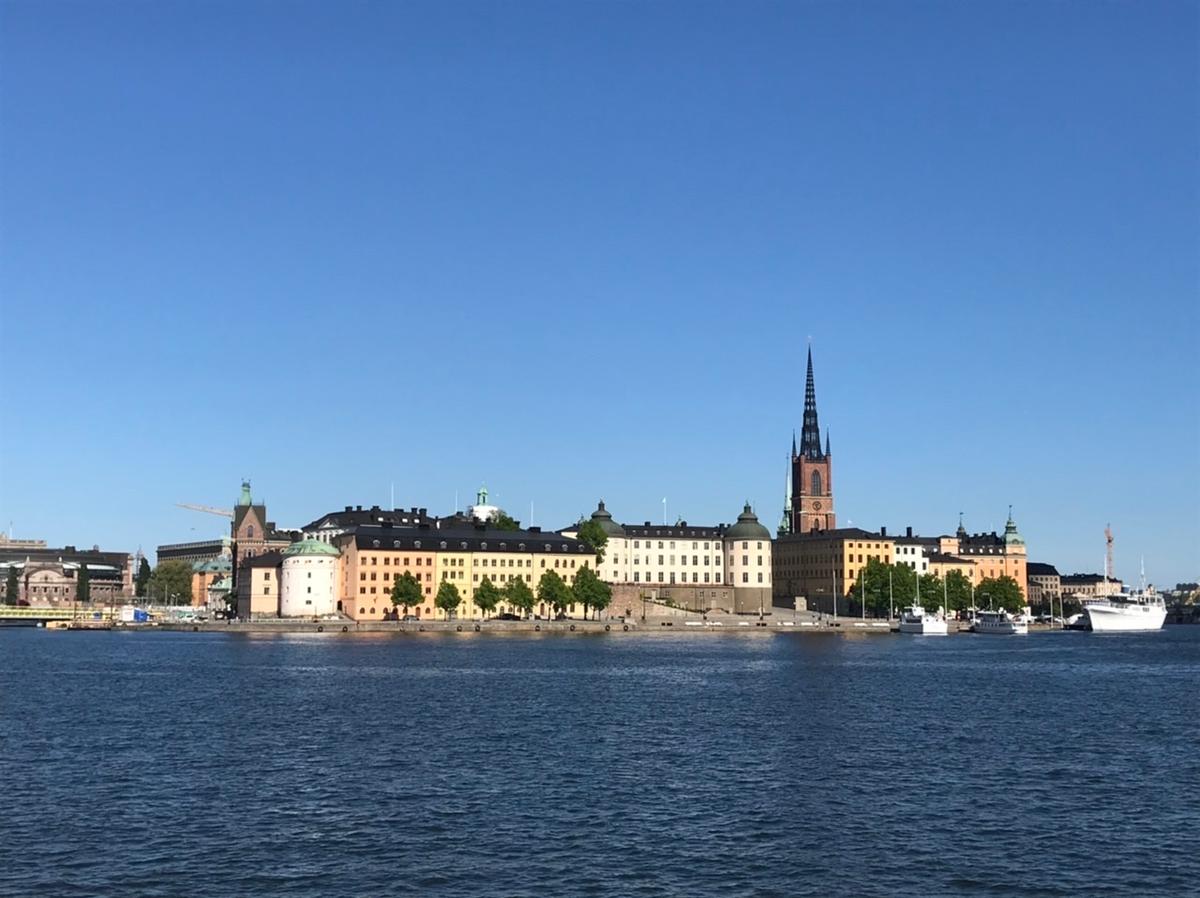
[0,0,1200,585]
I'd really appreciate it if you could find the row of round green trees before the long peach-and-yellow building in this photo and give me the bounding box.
[391,568,612,617]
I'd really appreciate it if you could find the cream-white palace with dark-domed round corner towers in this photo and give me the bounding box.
[562,501,772,613]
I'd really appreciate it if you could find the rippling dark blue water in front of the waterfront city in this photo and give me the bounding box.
[0,627,1200,898]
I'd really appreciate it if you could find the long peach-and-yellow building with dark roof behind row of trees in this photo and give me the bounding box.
[336,521,595,621]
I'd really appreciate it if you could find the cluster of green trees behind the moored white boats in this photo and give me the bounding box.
[847,558,1026,617]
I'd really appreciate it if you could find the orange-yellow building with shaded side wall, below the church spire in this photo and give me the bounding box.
[772,527,895,612]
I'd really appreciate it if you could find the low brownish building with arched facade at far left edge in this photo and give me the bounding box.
[0,540,133,605]
